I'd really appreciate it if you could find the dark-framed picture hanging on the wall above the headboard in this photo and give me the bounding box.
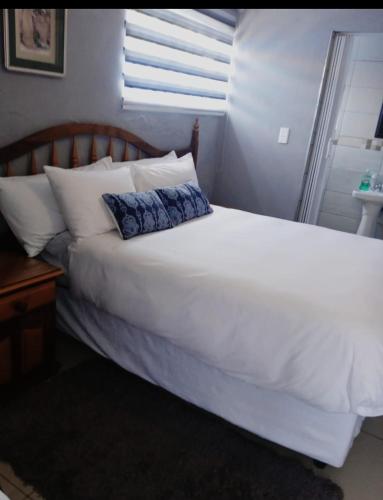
[4,9,67,77]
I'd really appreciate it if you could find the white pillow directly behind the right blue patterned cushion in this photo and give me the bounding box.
[131,153,198,191]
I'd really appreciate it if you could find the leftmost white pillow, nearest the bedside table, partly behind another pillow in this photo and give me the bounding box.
[0,156,112,257]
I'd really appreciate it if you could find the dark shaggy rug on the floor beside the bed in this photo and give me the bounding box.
[0,359,343,500]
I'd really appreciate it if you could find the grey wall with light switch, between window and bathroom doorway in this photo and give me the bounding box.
[214,9,383,219]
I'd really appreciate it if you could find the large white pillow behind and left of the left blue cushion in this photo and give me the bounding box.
[44,167,135,238]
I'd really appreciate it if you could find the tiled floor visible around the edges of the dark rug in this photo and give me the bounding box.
[0,335,383,500]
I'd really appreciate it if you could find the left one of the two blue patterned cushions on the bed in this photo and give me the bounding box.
[102,191,173,240]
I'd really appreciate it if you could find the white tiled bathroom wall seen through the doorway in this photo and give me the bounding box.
[318,34,383,238]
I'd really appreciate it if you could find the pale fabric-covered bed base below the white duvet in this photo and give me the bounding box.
[57,287,363,467]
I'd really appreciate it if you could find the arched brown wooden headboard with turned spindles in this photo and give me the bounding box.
[0,118,199,176]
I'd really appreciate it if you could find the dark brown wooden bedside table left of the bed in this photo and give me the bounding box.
[0,251,63,394]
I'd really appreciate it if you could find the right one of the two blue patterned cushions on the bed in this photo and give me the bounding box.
[155,182,213,226]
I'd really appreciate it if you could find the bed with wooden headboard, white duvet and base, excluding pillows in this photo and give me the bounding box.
[0,123,383,467]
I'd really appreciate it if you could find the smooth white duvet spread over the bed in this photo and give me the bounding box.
[70,206,383,416]
